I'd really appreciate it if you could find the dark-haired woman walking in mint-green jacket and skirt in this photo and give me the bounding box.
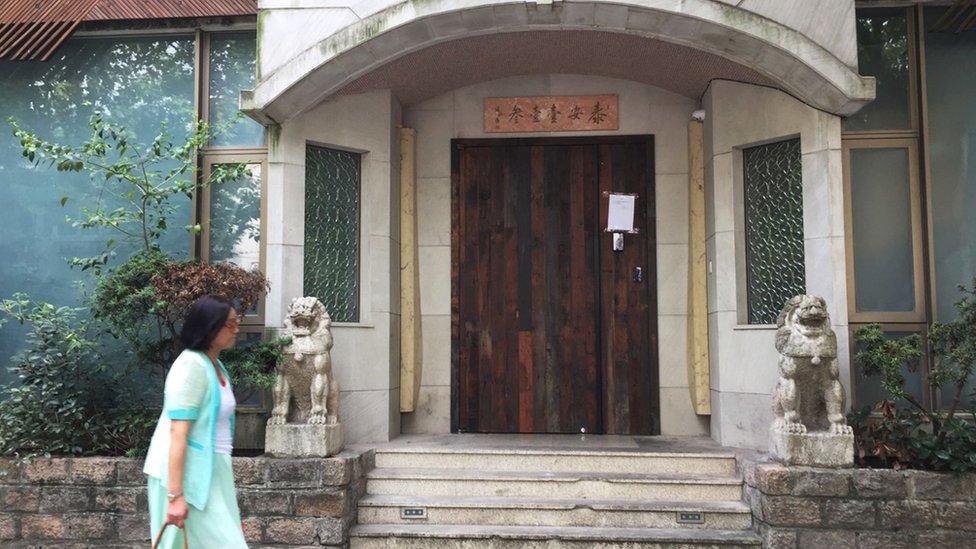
[143,296,247,549]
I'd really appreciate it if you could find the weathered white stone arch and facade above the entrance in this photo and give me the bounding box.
[248,0,874,122]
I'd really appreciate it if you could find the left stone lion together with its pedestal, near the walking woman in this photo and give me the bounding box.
[264,297,343,457]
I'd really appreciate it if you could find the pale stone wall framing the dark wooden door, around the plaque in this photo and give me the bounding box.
[403,74,696,435]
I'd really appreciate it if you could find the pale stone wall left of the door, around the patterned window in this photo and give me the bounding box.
[266,91,400,443]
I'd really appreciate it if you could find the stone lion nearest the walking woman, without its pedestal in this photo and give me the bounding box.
[268,297,339,425]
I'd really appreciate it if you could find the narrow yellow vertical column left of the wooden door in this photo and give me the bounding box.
[400,128,423,412]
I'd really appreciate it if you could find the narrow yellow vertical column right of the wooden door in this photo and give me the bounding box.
[688,121,712,415]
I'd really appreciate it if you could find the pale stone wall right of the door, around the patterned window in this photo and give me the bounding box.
[703,81,850,449]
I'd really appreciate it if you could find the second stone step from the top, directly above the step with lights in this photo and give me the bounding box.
[366,468,742,501]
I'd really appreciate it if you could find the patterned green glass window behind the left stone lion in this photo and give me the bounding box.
[305,145,360,322]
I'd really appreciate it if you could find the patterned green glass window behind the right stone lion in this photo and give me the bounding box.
[742,138,806,324]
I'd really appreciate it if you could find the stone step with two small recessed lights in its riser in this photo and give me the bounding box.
[359,496,752,530]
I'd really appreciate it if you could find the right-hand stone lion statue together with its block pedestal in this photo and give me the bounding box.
[769,295,854,467]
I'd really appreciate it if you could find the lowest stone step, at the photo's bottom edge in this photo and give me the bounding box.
[349,524,761,549]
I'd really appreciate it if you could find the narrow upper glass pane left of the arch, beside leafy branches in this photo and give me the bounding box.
[208,31,264,147]
